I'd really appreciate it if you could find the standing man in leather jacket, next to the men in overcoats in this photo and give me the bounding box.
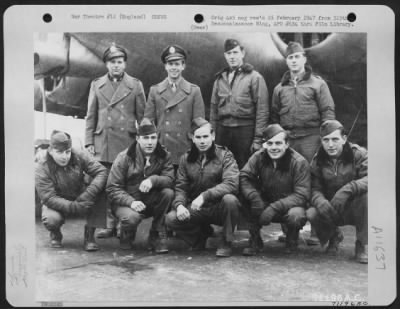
[210,39,269,168]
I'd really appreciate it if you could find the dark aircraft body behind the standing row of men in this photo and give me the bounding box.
[34,32,367,146]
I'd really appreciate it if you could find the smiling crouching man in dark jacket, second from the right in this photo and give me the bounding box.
[240,124,311,255]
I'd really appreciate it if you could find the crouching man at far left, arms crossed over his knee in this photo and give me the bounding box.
[35,131,108,251]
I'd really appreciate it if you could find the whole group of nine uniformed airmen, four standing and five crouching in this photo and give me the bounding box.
[35,39,368,263]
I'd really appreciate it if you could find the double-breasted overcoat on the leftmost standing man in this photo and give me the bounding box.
[85,73,146,163]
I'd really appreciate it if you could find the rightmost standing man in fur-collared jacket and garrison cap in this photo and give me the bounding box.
[271,42,335,245]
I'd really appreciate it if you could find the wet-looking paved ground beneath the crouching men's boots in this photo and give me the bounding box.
[36,218,368,306]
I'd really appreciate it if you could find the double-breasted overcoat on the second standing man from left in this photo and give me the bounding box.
[144,78,204,165]
